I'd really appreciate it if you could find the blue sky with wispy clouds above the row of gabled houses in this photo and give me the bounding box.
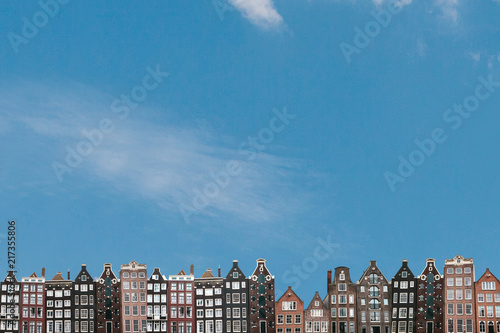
[0,0,500,302]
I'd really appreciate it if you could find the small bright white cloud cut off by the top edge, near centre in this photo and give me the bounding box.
[229,0,284,29]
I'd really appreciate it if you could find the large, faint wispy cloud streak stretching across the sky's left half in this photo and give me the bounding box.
[0,81,323,222]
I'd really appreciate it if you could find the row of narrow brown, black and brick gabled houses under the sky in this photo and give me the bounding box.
[0,256,500,333]
